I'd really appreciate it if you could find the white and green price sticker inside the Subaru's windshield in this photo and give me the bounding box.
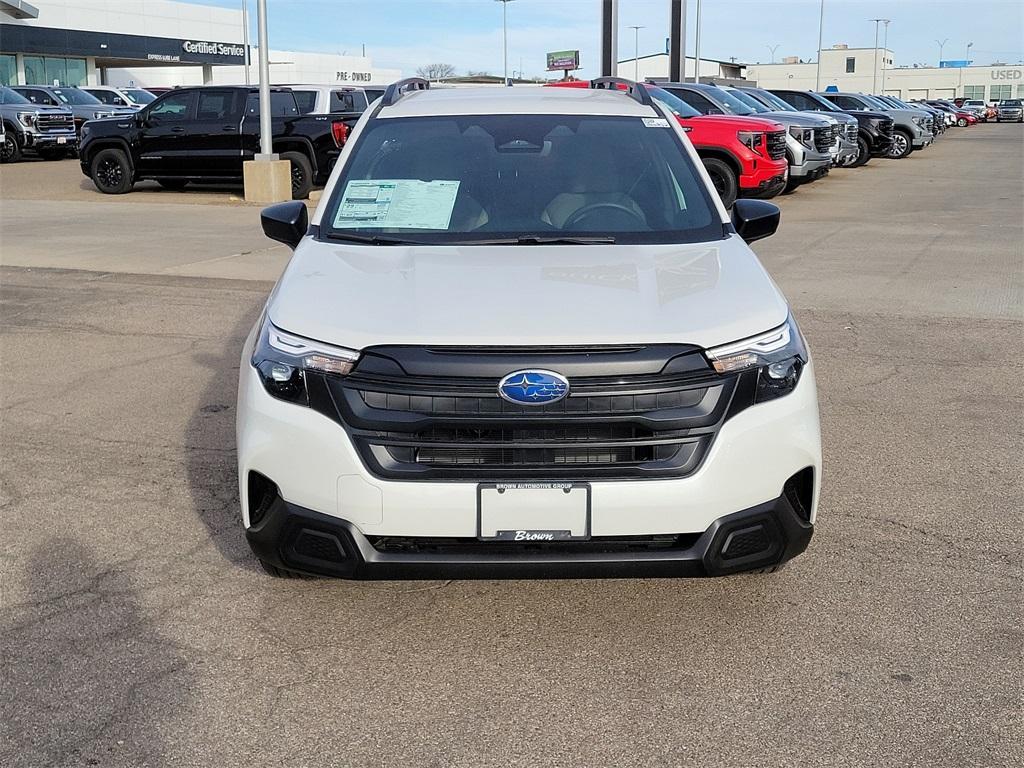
[334,178,459,229]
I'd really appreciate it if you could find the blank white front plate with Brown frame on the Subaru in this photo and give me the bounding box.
[476,482,590,542]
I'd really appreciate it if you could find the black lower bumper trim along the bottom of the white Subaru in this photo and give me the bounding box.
[246,487,814,579]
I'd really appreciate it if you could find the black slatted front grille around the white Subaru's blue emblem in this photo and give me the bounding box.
[307,345,753,480]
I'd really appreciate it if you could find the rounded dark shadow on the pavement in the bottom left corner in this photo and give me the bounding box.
[0,539,195,768]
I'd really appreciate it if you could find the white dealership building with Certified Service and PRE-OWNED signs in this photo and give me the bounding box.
[0,0,401,87]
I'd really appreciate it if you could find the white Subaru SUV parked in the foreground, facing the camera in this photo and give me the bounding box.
[238,78,821,579]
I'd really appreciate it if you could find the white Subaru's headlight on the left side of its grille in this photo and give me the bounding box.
[251,315,359,406]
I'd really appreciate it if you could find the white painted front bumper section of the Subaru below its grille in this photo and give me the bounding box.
[237,341,821,575]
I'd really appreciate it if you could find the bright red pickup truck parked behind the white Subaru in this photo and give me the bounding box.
[548,80,790,208]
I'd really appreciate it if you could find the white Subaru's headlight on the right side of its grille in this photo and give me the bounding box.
[706,314,808,402]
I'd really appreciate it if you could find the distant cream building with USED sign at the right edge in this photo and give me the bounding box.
[746,44,1024,100]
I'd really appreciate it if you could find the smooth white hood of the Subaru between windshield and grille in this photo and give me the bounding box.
[269,236,787,349]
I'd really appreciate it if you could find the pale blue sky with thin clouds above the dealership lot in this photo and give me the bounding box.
[199,0,1024,76]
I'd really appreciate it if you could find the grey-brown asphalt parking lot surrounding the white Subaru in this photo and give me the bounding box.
[0,124,1024,768]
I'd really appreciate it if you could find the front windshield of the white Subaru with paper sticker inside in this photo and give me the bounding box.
[322,115,724,245]
